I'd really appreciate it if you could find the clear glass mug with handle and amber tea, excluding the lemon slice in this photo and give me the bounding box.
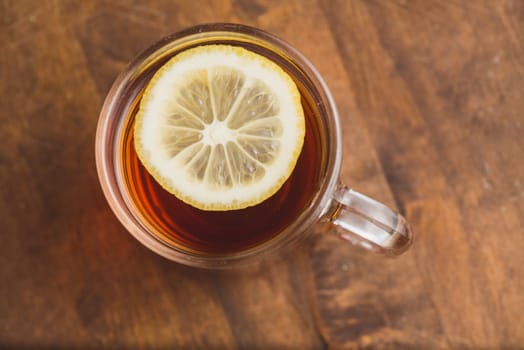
[96,23,412,268]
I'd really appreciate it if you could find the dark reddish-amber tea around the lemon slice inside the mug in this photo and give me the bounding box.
[120,58,325,255]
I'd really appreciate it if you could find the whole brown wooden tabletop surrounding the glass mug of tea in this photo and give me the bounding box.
[0,0,524,349]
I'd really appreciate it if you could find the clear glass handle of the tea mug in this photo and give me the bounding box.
[327,185,413,256]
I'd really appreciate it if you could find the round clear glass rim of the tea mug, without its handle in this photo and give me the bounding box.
[95,23,342,268]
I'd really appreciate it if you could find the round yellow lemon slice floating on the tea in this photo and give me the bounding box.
[134,45,305,210]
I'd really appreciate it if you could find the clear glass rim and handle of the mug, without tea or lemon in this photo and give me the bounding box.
[95,23,413,268]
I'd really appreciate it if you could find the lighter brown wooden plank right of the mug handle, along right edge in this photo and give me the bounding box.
[324,1,524,347]
